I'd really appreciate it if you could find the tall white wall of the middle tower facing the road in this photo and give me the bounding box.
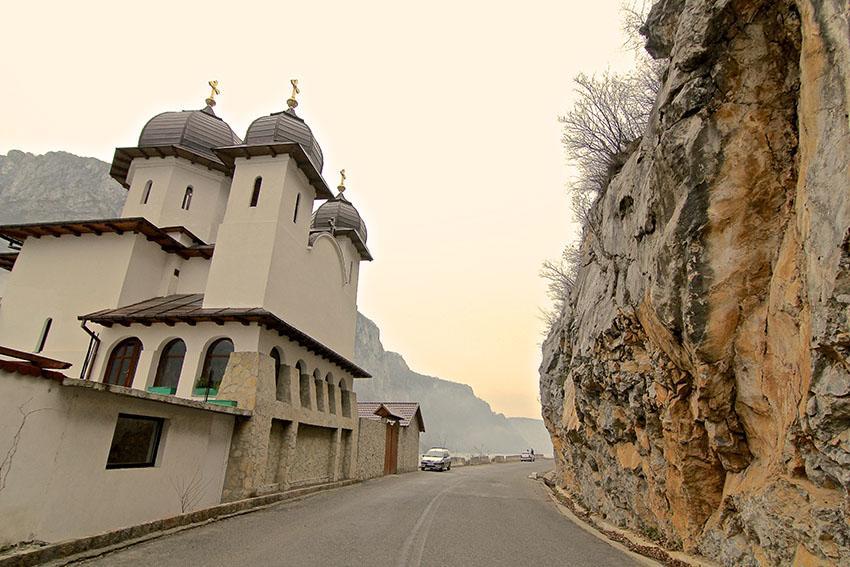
[204,155,364,358]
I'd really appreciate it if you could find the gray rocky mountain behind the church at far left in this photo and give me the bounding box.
[0,150,127,224]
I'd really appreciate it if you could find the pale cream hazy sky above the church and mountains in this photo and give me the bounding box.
[0,0,632,419]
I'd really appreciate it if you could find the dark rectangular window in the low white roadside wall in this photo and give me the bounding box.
[106,413,165,469]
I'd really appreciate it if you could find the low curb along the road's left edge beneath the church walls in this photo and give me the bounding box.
[0,480,360,567]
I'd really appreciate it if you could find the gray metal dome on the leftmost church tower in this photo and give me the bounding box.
[139,106,242,161]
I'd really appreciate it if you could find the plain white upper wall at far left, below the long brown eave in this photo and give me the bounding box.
[0,233,209,376]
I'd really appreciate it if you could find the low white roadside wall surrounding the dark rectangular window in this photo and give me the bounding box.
[0,371,234,547]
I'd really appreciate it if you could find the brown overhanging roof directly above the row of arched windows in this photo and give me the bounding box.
[78,293,371,378]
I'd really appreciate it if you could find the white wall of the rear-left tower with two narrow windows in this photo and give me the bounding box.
[121,157,230,243]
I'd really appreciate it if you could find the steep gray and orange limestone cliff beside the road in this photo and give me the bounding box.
[540,0,850,565]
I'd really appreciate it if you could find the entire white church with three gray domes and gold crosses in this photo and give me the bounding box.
[0,83,372,547]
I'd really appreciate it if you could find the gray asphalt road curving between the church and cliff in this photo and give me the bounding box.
[78,461,636,567]
